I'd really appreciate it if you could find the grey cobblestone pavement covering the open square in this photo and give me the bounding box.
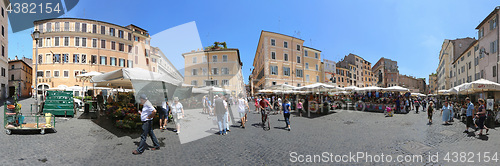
[0,99,500,165]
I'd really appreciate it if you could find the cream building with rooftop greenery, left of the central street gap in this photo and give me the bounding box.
[182,48,246,96]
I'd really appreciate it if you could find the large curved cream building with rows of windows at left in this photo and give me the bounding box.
[33,18,157,92]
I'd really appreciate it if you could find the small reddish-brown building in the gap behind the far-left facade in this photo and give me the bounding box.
[9,56,33,97]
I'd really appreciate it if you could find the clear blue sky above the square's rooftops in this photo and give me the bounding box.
[9,0,500,83]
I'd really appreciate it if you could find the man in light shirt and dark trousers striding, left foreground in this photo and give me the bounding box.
[132,94,160,155]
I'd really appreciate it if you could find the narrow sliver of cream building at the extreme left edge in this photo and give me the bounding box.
[0,0,10,100]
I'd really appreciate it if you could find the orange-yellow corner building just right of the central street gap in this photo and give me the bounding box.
[250,31,321,90]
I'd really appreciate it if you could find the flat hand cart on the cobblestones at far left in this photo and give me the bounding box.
[3,104,57,135]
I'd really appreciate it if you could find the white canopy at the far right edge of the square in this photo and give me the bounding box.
[458,79,500,94]
